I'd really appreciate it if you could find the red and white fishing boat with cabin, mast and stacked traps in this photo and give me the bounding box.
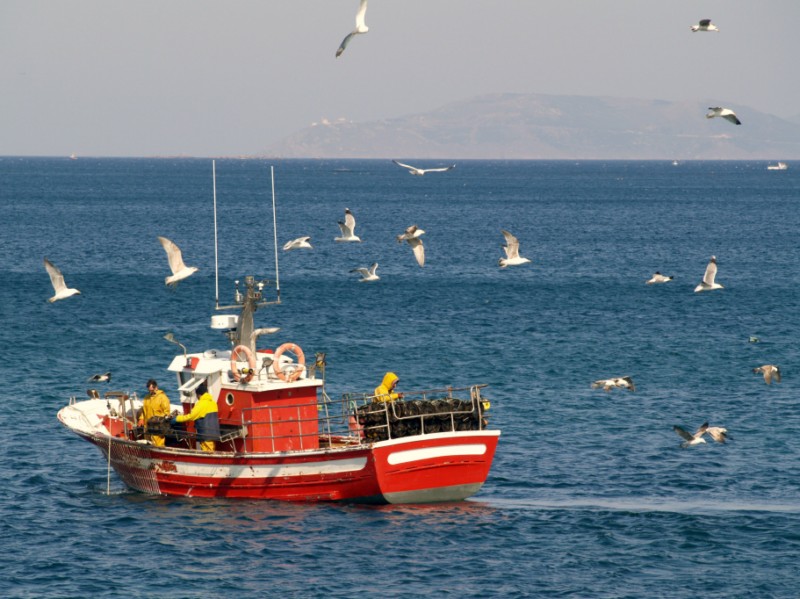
[58,277,500,503]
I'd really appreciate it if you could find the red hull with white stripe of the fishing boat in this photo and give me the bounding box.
[75,430,500,504]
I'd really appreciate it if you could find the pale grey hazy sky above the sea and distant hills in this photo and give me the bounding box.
[0,0,800,156]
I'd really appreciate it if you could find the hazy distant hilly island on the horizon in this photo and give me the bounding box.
[263,94,800,160]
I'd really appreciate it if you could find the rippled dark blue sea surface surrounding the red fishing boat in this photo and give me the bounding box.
[0,157,800,598]
